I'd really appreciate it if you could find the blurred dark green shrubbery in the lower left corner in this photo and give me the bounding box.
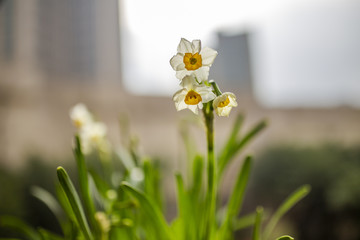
[0,155,77,237]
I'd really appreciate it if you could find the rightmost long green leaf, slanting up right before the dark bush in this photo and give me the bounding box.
[264,185,310,240]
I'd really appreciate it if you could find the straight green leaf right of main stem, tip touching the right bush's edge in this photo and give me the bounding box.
[220,156,252,239]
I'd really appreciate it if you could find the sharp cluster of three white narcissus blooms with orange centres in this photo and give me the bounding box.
[170,38,237,116]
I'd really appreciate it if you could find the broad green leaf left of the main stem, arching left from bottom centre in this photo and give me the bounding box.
[121,183,173,240]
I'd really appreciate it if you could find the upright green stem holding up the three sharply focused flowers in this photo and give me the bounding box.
[203,102,217,239]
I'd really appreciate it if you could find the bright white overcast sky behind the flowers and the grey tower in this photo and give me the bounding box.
[119,0,360,107]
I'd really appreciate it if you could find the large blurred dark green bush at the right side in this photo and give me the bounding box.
[247,144,360,240]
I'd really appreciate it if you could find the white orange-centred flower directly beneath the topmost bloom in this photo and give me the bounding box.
[173,76,216,114]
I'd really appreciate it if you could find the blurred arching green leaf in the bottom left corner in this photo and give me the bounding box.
[0,216,41,240]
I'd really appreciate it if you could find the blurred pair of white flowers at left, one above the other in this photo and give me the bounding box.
[70,103,108,154]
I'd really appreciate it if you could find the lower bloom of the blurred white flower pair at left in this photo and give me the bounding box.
[80,122,107,154]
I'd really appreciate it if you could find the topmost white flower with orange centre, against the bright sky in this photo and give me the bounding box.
[170,38,218,81]
